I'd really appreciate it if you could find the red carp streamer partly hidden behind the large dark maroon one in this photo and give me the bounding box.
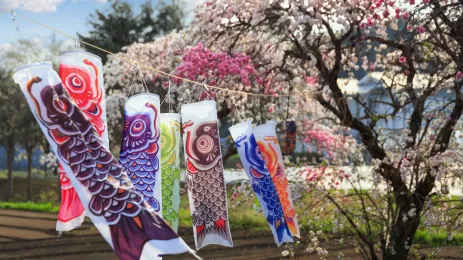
[56,50,109,231]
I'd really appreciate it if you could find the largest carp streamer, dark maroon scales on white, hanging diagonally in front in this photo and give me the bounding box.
[13,62,194,260]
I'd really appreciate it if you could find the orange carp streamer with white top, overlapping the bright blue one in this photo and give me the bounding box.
[253,120,300,238]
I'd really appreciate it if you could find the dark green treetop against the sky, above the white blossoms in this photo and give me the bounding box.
[77,0,184,62]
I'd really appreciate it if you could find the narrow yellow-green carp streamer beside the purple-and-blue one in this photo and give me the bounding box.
[161,113,181,232]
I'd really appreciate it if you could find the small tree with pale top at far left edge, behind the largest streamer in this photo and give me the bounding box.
[0,37,64,199]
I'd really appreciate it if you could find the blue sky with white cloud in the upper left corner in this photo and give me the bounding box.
[0,0,201,45]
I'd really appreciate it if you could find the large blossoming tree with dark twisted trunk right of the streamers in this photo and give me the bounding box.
[190,0,463,259]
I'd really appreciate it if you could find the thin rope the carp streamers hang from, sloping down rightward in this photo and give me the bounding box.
[0,5,300,98]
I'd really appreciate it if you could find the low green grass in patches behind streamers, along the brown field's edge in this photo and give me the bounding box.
[0,175,463,247]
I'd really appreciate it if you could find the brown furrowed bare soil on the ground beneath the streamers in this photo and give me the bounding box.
[0,210,460,260]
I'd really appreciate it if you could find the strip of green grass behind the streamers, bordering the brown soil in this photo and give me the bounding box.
[0,172,463,246]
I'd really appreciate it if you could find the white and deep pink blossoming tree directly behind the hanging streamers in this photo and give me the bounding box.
[105,30,302,159]
